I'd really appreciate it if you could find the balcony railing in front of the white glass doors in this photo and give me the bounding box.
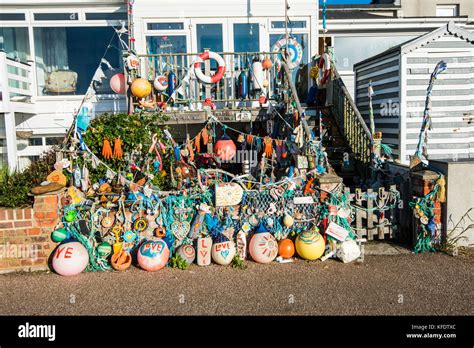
[140,52,279,108]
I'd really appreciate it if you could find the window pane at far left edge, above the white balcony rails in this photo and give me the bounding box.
[0,28,31,62]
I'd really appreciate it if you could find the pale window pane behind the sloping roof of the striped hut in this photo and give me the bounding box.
[334,36,415,71]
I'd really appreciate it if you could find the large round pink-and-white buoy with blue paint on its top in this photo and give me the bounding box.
[137,240,170,272]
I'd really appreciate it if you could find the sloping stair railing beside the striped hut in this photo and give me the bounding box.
[330,65,373,174]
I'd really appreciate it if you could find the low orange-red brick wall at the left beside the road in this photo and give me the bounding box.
[0,194,59,273]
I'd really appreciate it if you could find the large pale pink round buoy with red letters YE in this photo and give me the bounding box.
[52,242,89,277]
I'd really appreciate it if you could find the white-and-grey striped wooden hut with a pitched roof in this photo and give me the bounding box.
[354,22,474,163]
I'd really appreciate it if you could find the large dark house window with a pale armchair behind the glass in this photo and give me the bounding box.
[34,27,122,96]
